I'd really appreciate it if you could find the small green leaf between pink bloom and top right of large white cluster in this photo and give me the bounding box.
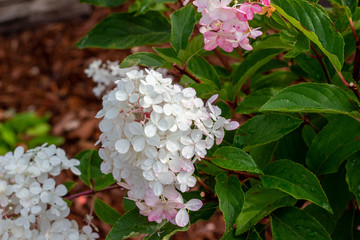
[188,55,220,88]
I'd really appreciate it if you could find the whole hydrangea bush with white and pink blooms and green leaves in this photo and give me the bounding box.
[0,0,360,240]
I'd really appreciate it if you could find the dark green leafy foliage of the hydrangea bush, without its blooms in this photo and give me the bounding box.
[72,0,360,240]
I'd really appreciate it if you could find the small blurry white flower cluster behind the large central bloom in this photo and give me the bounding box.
[85,59,139,97]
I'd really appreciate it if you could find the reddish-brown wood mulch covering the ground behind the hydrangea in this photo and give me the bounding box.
[0,4,224,240]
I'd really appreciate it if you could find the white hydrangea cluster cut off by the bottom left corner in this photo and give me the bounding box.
[0,145,98,240]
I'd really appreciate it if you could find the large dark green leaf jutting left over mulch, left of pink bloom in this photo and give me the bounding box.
[76,11,170,49]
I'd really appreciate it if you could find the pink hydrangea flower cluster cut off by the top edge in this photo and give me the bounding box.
[184,0,270,52]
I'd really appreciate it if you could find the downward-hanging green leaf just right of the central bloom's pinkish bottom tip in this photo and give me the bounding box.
[215,174,244,231]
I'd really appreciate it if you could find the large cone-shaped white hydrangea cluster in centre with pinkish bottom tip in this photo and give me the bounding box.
[97,69,239,226]
